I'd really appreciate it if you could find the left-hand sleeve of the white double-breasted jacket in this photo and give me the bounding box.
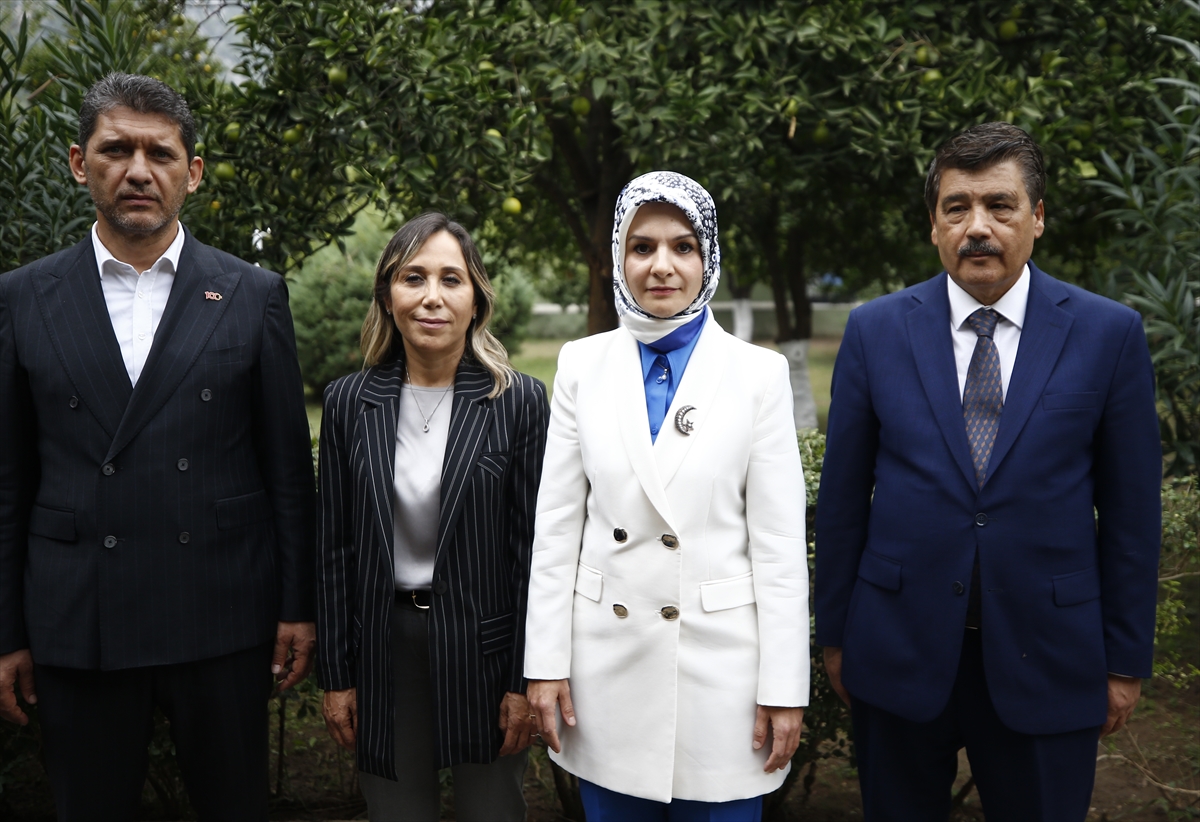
[524,343,590,679]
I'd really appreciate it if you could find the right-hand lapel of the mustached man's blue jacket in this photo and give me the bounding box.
[988,262,1075,476]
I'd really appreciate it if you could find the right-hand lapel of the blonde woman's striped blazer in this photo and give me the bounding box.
[434,356,493,564]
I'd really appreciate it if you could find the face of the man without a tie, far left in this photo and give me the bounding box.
[71,107,204,242]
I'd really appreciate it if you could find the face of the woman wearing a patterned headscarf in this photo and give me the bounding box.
[625,203,704,318]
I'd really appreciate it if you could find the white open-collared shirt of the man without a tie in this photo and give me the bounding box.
[91,222,184,385]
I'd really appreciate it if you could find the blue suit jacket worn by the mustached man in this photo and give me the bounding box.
[815,263,1162,733]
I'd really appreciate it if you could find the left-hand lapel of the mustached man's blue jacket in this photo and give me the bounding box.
[905,272,979,492]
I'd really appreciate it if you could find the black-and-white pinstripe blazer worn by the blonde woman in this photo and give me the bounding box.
[317,356,550,779]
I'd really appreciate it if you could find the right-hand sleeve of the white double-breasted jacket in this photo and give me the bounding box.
[746,356,809,708]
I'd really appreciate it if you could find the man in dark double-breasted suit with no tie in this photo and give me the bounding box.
[0,74,316,821]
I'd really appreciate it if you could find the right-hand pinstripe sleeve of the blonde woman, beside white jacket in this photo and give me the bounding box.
[505,379,550,694]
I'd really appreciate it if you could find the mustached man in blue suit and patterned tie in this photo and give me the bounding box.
[815,122,1162,822]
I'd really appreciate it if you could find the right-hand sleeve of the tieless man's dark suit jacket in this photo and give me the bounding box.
[253,277,316,622]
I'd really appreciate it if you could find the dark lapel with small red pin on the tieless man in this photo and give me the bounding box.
[107,229,241,460]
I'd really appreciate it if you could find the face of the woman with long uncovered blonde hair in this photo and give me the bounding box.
[386,232,475,356]
